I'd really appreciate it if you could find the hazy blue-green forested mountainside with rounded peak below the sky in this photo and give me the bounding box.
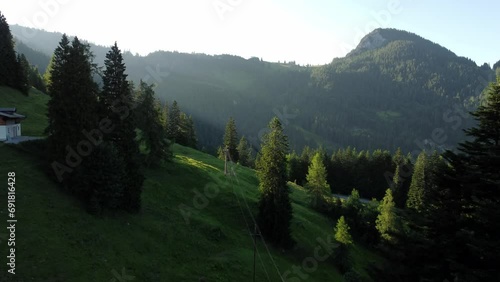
[12,26,495,154]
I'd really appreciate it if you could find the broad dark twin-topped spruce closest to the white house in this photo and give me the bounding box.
[46,35,99,189]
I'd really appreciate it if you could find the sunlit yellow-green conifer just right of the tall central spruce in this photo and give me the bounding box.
[306,152,330,208]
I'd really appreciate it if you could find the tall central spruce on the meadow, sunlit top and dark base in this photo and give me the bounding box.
[256,117,294,248]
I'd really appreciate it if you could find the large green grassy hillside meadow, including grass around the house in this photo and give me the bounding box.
[0,89,379,282]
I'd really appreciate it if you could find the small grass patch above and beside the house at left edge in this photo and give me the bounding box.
[0,86,49,136]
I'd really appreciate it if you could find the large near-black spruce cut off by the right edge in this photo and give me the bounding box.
[432,77,500,281]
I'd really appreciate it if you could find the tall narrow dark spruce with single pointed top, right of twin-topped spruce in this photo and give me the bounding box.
[99,42,144,212]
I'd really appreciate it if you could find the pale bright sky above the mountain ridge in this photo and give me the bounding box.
[0,0,500,64]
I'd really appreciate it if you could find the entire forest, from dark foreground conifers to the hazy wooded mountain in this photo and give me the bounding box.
[0,10,500,281]
